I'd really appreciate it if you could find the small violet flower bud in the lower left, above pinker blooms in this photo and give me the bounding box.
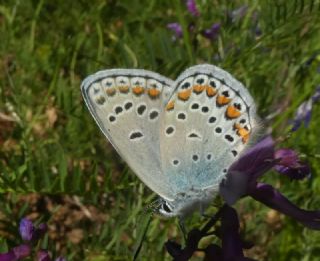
[19,218,47,242]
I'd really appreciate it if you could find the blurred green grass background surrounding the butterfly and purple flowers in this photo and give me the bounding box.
[0,0,320,261]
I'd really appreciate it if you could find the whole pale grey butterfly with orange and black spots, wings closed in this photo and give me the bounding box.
[81,64,258,217]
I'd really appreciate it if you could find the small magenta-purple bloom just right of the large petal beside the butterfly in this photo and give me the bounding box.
[274,149,311,179]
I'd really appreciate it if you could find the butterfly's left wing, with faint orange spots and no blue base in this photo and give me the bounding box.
[81,69,173,200]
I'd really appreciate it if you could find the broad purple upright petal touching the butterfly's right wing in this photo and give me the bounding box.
[220,136,276,205]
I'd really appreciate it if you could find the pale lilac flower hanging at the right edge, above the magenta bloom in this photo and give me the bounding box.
[291,86,320,131]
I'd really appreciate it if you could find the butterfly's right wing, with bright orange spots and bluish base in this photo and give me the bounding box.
[160,64,257,193]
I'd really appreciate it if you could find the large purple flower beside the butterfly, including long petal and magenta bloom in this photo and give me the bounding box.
[220,137,320,230]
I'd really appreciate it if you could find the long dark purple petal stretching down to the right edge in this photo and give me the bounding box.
[249,183,320,230]
